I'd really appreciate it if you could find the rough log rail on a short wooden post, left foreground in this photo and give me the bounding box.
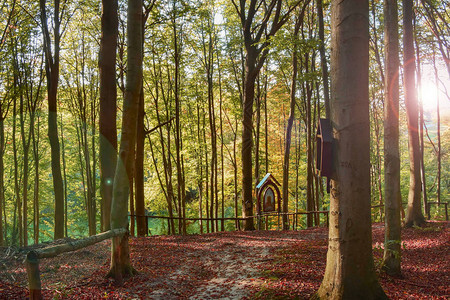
[25,228,127,300]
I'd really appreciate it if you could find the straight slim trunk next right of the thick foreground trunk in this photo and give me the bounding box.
[382,0,401,275]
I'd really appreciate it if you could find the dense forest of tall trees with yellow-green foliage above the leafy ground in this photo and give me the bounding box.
[0,0,450,299]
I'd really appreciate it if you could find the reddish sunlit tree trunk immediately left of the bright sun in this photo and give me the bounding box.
[403,0,425,227]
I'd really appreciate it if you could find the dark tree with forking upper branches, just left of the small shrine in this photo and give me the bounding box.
[232,0,300,230]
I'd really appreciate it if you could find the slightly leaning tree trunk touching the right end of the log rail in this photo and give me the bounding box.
[109,0,143,284]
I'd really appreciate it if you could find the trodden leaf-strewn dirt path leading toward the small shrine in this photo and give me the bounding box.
[142,233,276,299]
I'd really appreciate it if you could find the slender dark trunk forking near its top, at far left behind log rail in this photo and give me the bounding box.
[40,0,64,239]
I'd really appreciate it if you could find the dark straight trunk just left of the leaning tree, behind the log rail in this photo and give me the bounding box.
[99,0,119,231]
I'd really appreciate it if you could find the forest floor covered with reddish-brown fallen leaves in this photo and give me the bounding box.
[0,222,450,299]
